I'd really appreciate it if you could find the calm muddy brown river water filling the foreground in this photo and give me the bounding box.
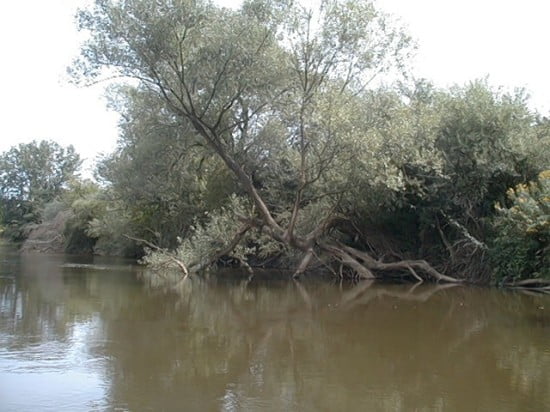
[0,241,550,411]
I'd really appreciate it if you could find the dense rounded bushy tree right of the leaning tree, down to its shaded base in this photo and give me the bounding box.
[357,81,550,280]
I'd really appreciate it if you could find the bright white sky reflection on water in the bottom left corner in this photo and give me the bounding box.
[0,318,108,411]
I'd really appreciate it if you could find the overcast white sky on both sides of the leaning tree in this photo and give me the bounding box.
[0,0,550,173]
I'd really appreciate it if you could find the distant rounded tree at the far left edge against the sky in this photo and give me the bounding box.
[0,140,81,240]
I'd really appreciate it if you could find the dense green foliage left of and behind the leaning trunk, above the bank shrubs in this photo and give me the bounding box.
[94,87,234,253]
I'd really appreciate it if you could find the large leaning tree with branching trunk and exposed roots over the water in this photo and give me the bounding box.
[71,0,462,281]
